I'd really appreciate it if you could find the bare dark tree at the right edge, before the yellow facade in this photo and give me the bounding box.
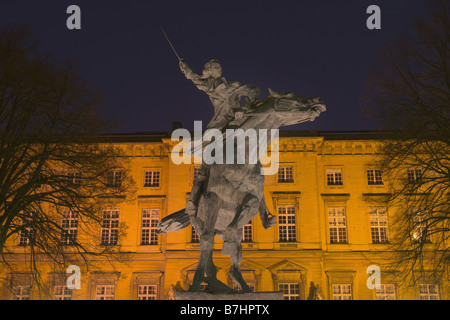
[363,1,450,284]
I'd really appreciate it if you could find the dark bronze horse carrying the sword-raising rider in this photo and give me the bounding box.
[157,89,326,293]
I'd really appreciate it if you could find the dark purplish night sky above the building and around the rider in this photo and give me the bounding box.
[0,0,428,133]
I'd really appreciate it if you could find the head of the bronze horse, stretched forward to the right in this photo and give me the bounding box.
[269,89,326,126]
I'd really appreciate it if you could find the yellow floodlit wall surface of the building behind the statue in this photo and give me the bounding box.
[0,132,450,300]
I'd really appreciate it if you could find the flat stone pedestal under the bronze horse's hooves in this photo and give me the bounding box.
[175,291,284,300]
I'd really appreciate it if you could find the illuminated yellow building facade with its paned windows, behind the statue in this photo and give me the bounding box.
[0,131,450,300]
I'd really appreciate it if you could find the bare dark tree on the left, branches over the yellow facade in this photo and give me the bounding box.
[0,25,133,298]
